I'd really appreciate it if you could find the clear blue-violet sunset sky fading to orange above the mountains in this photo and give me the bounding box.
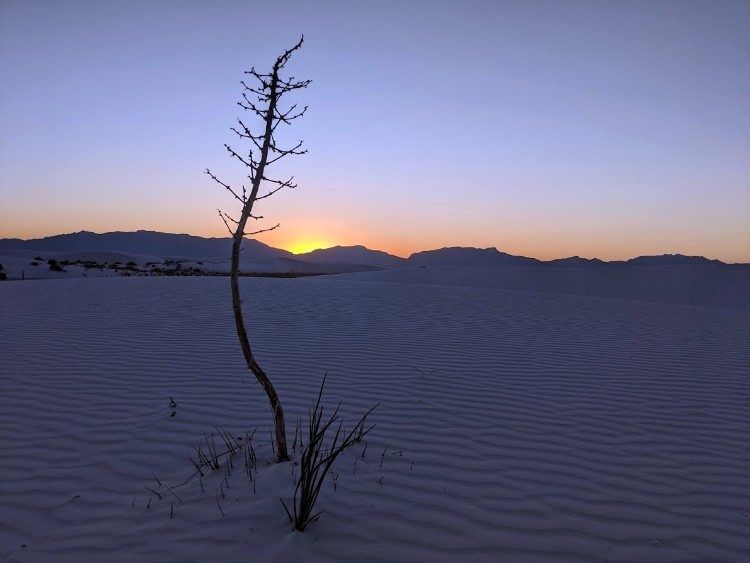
[0,0,750,262]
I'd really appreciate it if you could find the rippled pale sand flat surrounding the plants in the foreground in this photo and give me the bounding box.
[0,272,750,561]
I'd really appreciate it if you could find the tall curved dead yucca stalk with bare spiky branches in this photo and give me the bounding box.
[206,37,310,461]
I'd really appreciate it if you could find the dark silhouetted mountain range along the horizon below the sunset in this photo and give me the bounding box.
[0,230,736,271]
